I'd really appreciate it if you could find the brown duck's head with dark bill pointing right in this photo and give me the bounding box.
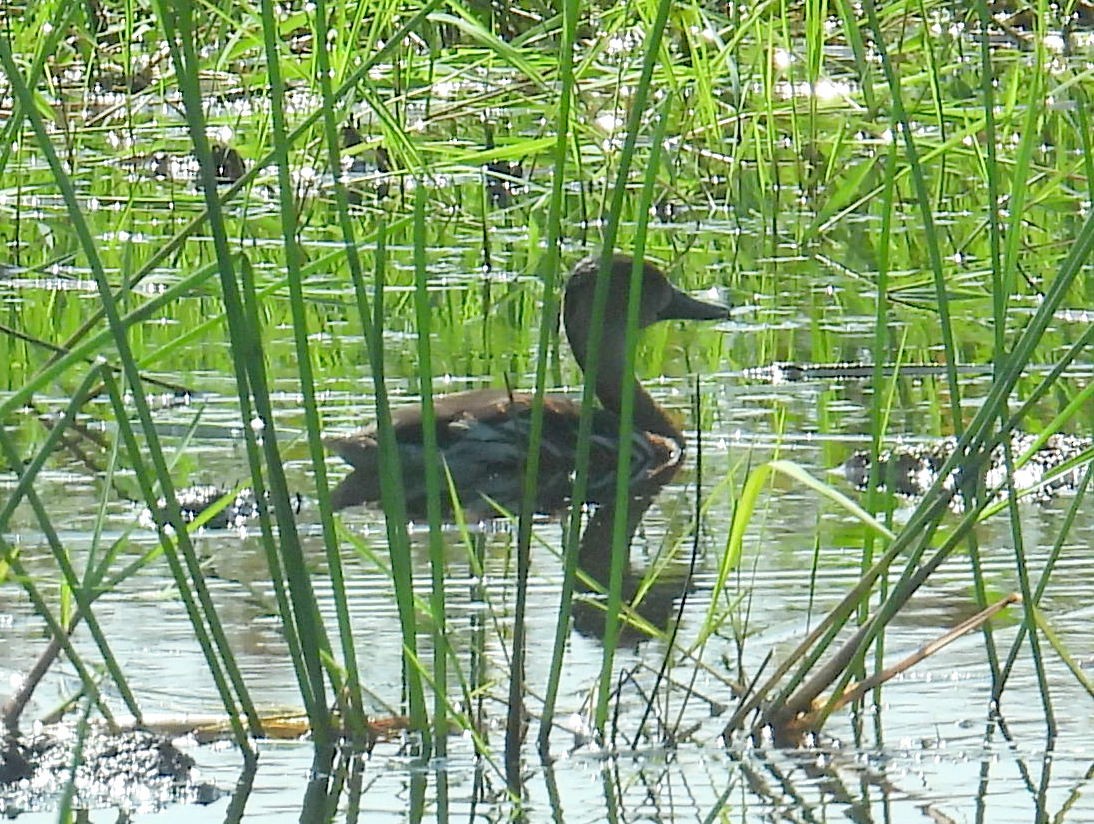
[562,255,729,360]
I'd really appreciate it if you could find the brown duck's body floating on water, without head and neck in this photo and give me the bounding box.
[327,390,682,519]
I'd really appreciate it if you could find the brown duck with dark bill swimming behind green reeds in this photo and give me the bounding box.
[325,254,729,521]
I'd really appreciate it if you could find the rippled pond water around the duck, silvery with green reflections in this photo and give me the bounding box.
[0,3,1094,823]
